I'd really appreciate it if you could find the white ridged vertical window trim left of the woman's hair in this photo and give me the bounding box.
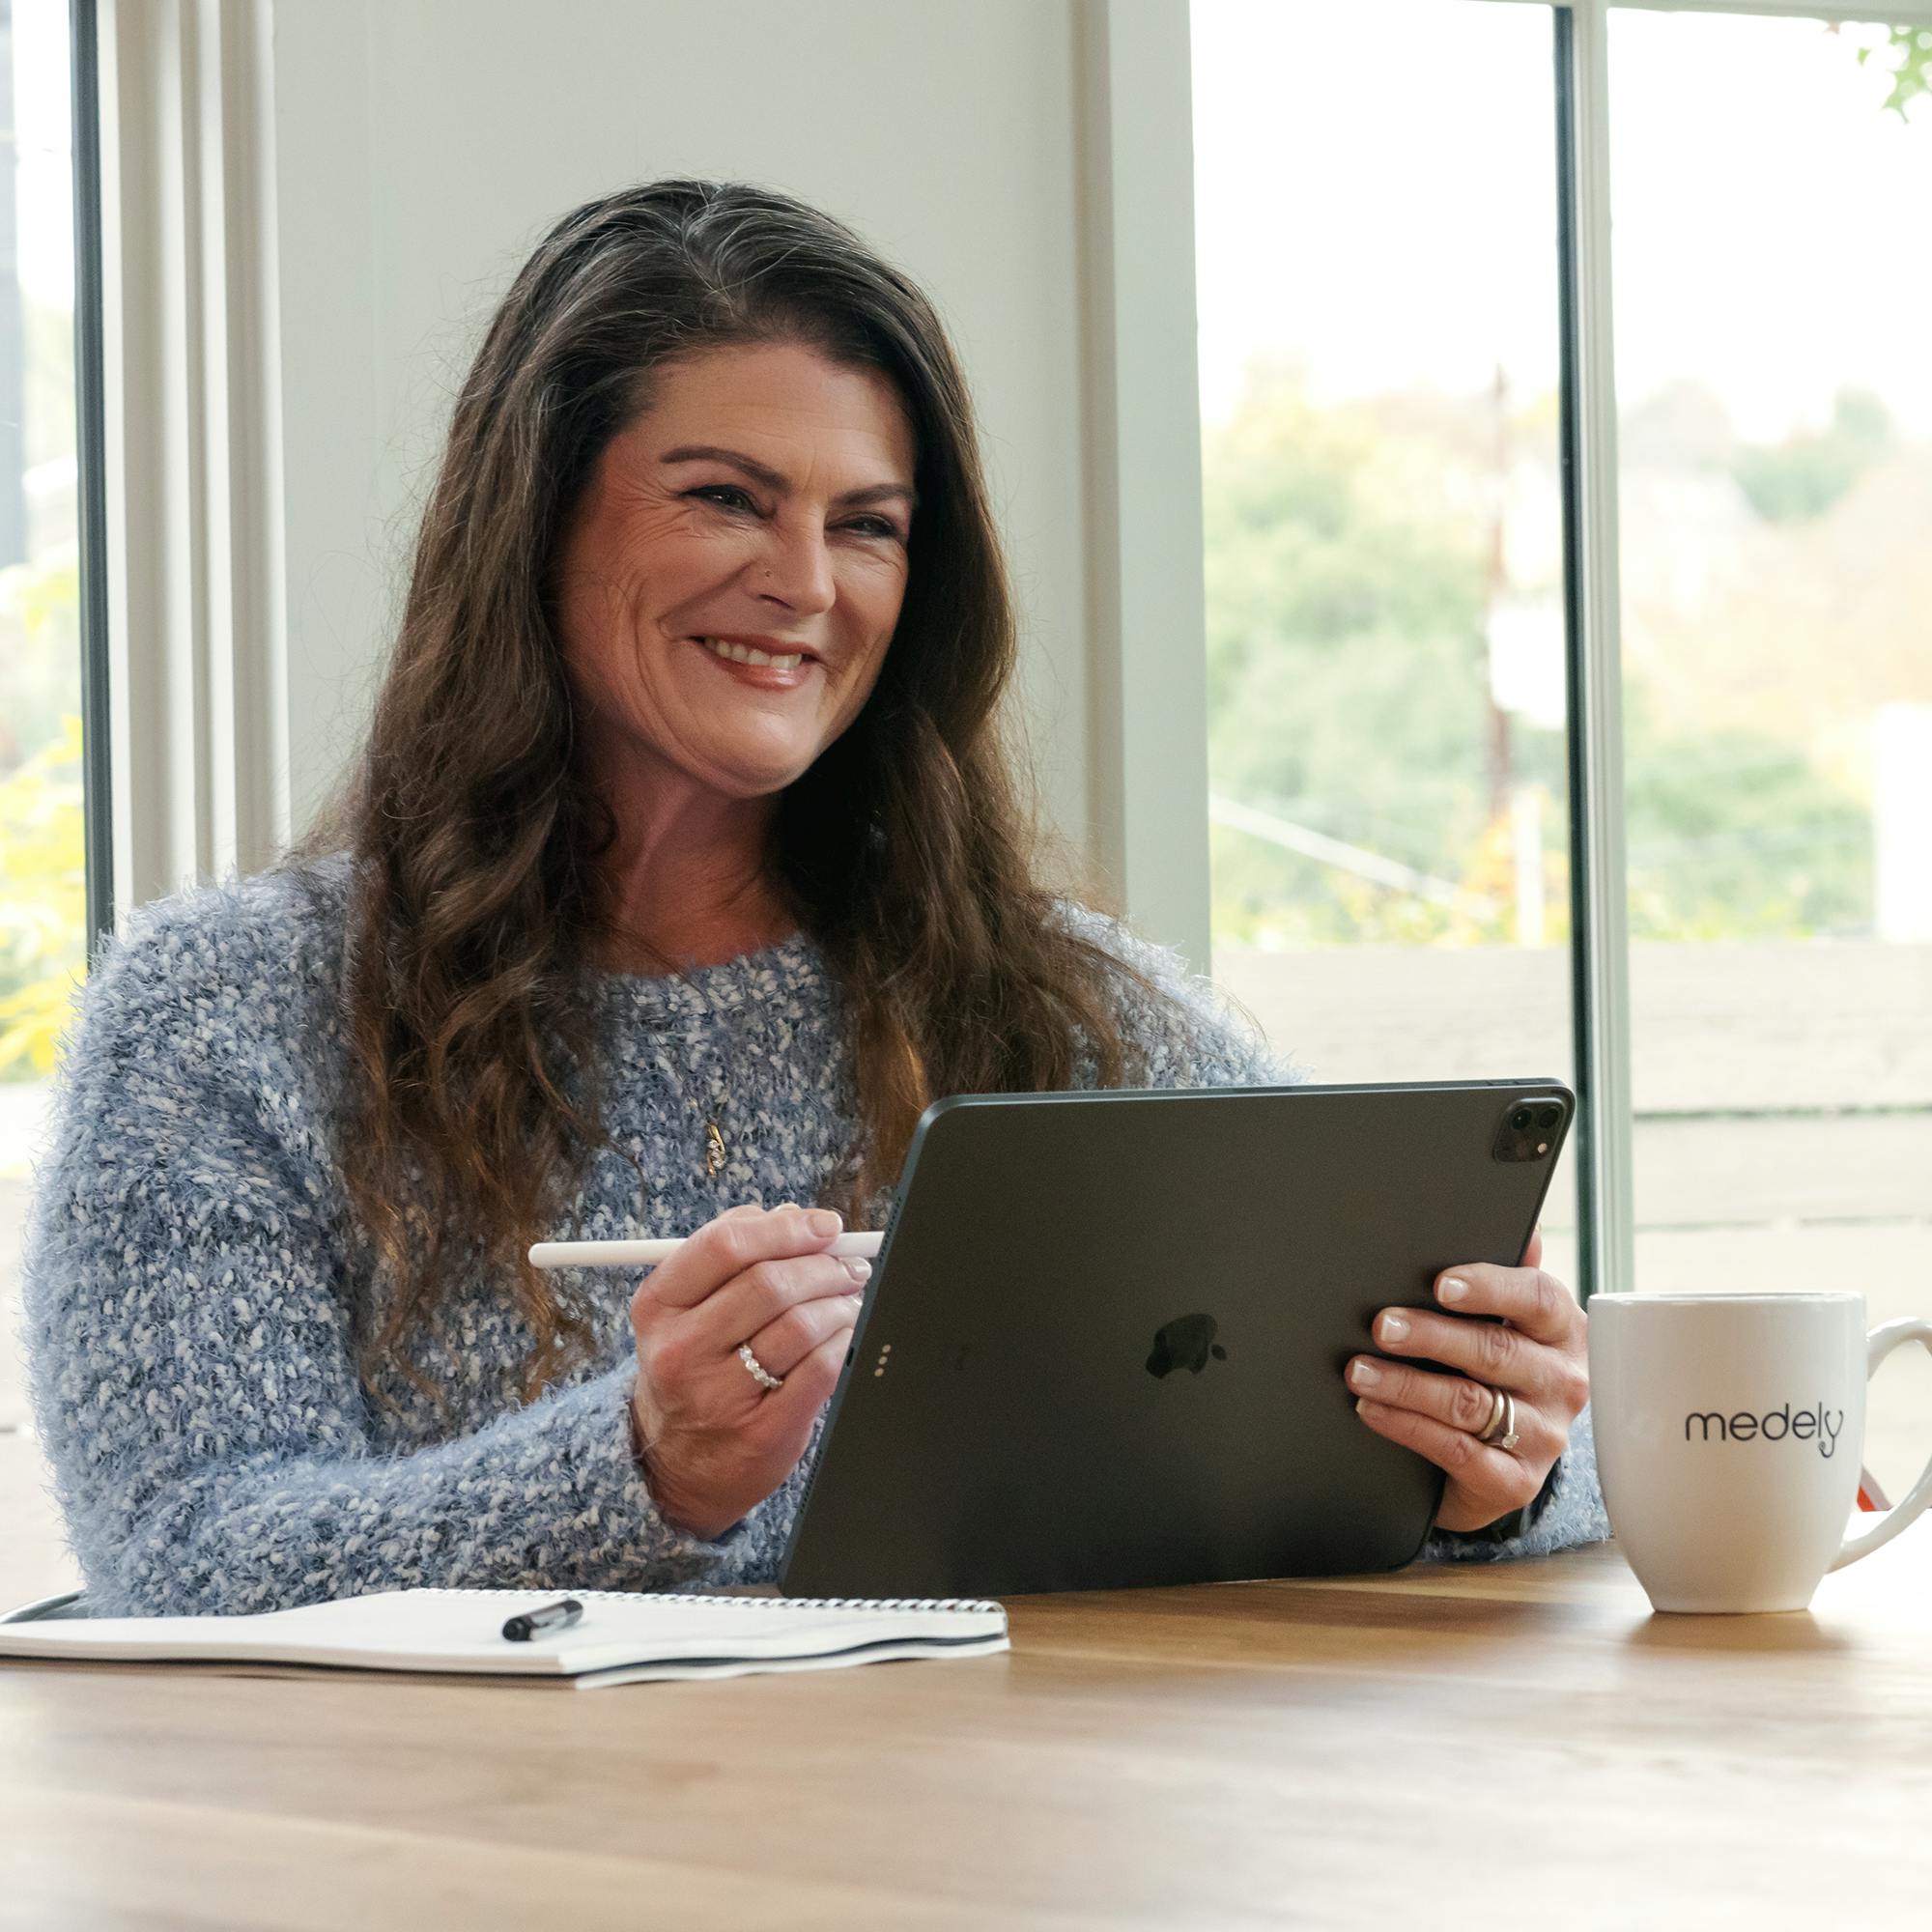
[99,0,288,910]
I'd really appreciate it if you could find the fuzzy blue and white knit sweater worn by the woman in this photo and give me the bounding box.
[27,862,1605,1615]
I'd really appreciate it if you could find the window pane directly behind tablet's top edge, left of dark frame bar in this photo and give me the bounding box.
[1194,0,1577,1281]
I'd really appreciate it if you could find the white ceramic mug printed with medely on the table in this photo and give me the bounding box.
[1590,1291,1932,1611]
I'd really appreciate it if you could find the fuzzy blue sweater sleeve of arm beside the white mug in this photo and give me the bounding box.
[1072,908,1609,1563]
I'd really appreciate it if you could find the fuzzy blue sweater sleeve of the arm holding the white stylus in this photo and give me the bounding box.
[25,889,771,1615]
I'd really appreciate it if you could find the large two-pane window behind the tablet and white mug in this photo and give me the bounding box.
[1194,0,1932,1488]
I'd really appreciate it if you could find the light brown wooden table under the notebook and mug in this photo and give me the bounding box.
[0,1522,1932,1932]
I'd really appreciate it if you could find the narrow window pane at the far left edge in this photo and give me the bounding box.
[0,0,87,1602]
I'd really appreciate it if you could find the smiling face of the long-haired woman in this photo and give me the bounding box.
[558,344,914,798]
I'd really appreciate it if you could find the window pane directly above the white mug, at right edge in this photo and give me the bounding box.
[1609,12,1932,1488]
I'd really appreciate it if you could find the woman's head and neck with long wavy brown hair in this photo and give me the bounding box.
[284,182,1190,1391]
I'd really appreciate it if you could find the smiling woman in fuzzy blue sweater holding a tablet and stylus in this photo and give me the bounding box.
[29,182,1602,1613]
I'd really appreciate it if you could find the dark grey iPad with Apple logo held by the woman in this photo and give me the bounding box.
[782,1080,1575,1596]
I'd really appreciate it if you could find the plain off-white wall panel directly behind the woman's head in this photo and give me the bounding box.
[274,0,1105,840]
